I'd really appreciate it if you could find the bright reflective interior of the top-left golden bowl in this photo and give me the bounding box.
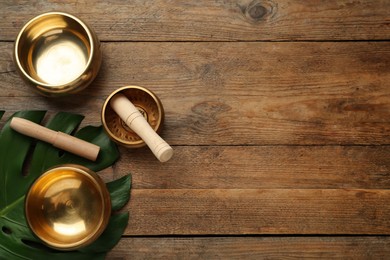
[16,13,92,86]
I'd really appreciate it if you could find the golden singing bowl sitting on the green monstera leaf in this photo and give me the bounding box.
[25,165,111,250]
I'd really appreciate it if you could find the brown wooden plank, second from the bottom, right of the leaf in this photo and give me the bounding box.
[124,189,390,236]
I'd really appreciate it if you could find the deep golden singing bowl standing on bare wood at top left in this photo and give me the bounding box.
[14,12,102,96]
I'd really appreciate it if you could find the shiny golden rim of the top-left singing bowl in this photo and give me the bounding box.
[14,12,96,93]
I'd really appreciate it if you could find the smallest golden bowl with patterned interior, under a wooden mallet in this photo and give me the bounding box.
[101,86,164,148]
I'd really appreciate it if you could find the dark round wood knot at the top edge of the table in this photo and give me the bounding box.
[240,0,277,22]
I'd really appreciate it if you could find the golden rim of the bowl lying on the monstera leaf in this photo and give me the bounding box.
[24,164,111,251]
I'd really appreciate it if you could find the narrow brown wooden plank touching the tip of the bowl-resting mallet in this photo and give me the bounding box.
[109,146,390,189]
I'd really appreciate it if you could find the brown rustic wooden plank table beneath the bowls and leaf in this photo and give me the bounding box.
[0,0,390,259]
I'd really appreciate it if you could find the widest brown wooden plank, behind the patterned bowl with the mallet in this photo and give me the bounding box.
[0,42,390,145]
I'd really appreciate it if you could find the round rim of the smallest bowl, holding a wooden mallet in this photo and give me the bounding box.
[101,85,164,148]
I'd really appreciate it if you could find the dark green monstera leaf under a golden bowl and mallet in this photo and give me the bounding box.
[0,111,131,259]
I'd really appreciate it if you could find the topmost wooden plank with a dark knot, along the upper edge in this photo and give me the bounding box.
[0,0,390,41]
